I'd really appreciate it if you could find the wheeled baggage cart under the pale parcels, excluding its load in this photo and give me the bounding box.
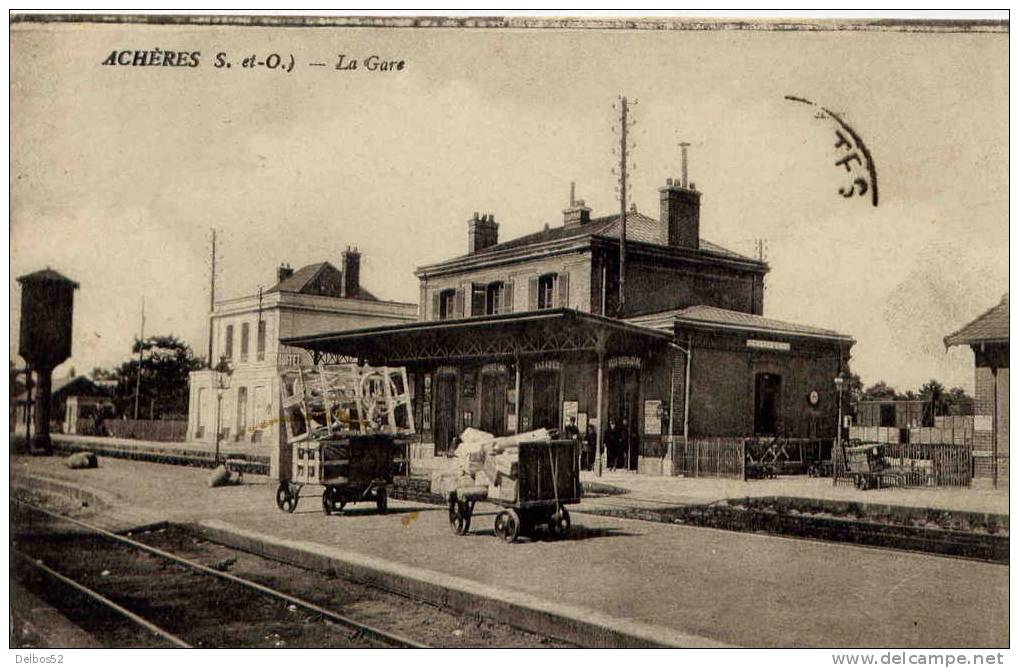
[448,440,582,543]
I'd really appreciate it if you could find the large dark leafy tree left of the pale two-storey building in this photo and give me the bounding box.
[113,334,205,419]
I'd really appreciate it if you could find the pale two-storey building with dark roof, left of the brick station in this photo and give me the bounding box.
[187,247,417,452]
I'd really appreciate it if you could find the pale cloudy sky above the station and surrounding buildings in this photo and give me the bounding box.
[10,20,1009,390]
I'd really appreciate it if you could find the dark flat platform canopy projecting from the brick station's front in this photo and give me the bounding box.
[281,309,673,366]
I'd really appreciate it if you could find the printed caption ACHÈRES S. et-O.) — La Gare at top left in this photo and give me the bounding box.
[102,49,407,72]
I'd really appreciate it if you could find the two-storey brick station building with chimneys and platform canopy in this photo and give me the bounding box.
[283,179,853,475]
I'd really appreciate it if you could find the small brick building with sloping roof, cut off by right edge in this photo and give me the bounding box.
[945,293,1009,487]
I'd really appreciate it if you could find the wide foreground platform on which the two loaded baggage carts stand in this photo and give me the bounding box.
[12,457,1009,647]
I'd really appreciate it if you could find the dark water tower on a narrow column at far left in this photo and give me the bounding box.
[17,267,77,453]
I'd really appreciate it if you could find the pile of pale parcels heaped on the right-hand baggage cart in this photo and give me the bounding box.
[432,427,551,503]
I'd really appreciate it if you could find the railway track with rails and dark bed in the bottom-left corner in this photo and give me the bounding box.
[11,498,429,648]
